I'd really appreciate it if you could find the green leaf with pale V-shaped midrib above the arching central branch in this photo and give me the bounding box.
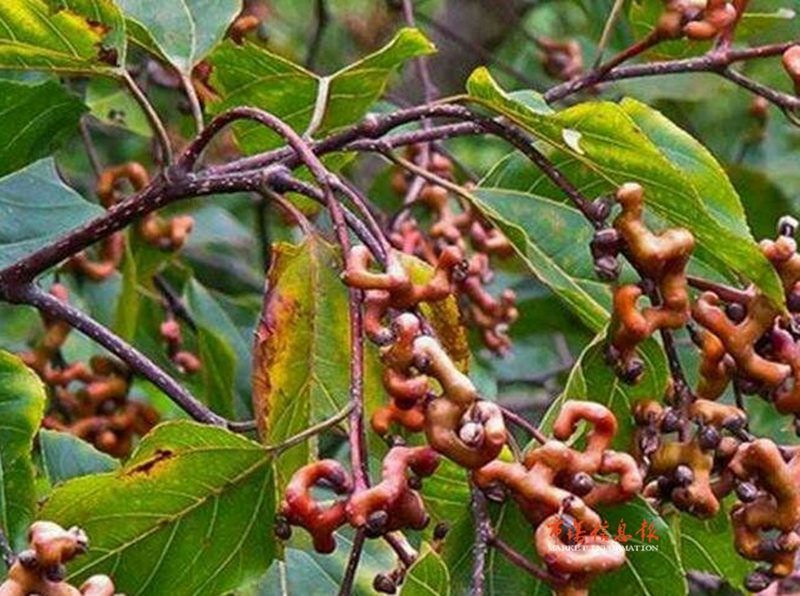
[208,29,433,152]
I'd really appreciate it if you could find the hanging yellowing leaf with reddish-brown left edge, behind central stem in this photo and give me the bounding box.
[253,235,385,490]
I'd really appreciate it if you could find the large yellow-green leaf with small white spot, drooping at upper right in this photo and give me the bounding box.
[468,68,783,304]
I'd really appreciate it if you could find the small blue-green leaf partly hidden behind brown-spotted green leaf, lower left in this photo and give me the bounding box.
[39,430,119,484]
